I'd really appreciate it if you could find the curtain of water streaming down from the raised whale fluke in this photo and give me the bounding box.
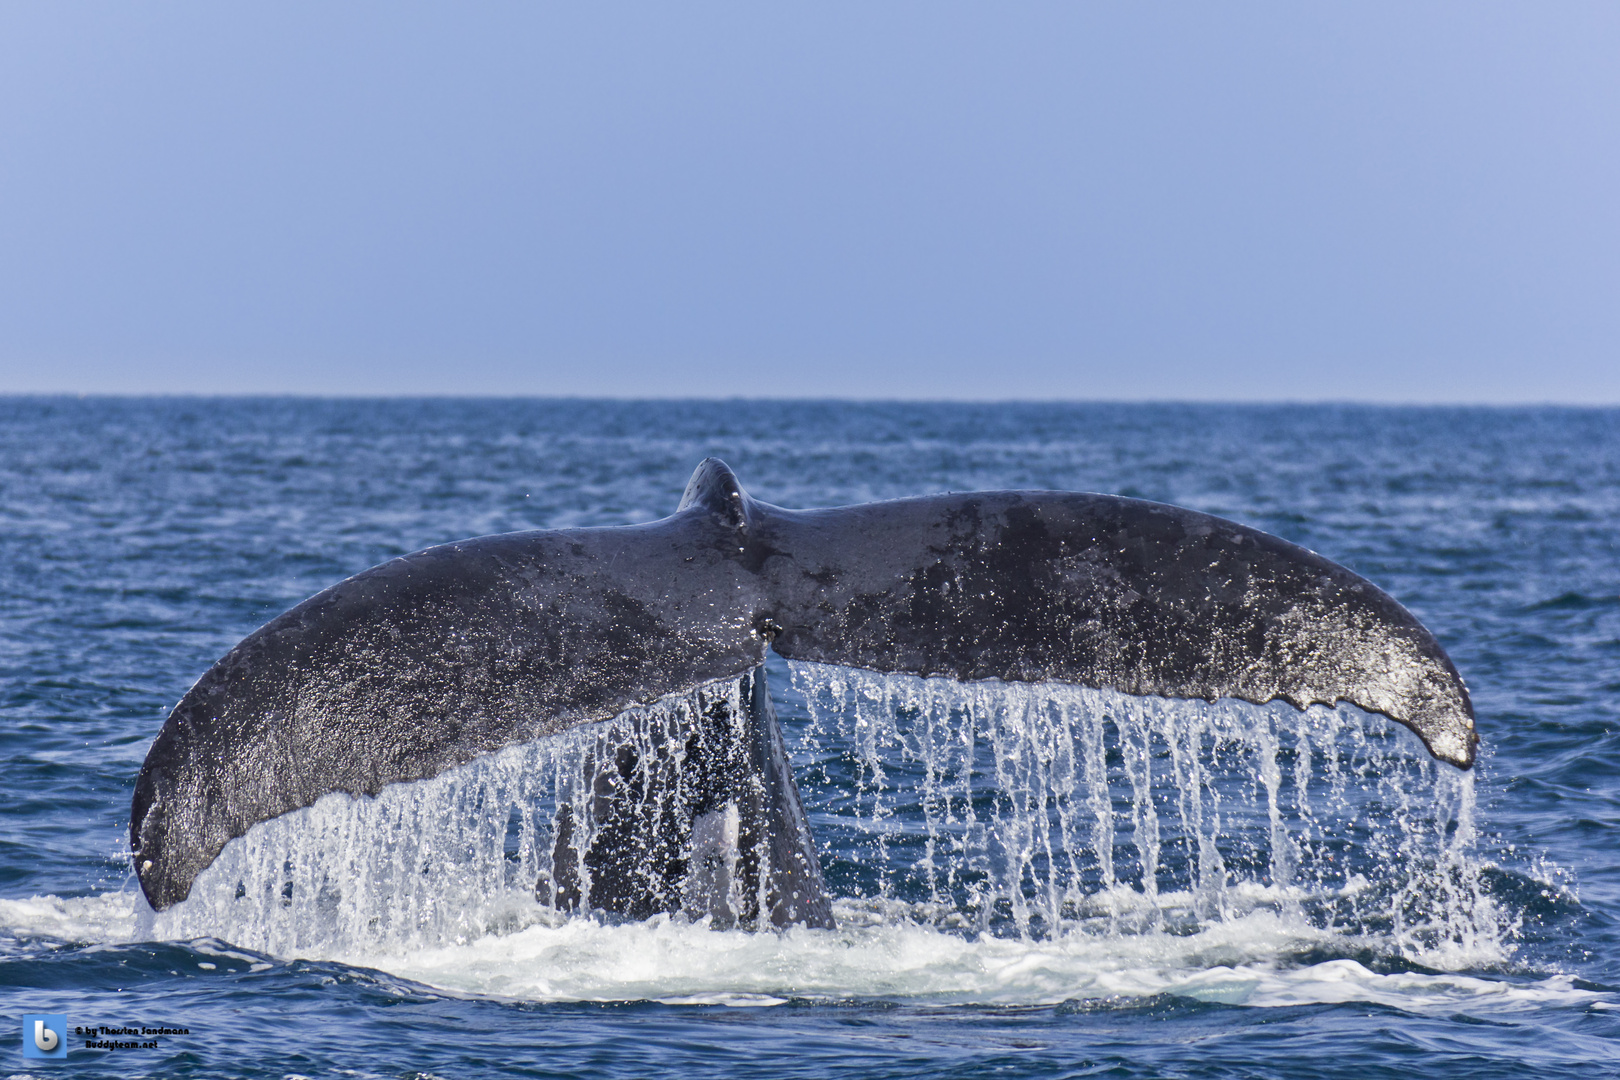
[157,664,1500,957]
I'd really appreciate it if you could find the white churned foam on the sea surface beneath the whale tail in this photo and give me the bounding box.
[0,892,1594,1015]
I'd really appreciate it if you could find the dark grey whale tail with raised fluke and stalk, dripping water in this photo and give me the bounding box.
[130,458,1477,926]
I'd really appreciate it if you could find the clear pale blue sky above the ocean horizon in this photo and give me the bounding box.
[0,0,1620,405]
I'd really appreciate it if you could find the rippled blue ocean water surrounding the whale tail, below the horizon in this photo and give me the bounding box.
[0,398,1620,1078]
